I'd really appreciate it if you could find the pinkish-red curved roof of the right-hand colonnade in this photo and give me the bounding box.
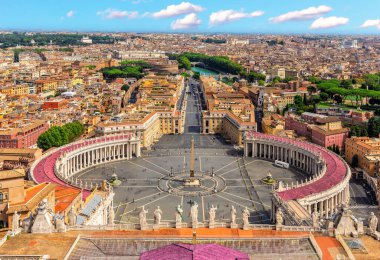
[246,131,347,201]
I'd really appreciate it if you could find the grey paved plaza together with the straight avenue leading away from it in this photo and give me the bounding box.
[76,79,305,224]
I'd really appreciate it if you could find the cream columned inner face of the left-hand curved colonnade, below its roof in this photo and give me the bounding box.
[56,140,141,179]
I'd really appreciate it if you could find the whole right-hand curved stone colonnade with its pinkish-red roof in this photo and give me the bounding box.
[244,131,351,218]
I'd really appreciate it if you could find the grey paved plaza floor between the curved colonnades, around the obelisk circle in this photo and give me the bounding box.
[77,149,304,223]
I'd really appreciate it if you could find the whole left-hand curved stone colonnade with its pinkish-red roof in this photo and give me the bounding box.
[30,134,141,198]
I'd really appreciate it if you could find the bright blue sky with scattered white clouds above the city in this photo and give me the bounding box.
[0,0,380,35]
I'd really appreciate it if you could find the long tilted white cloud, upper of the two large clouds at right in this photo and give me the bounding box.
[270,5,332,23]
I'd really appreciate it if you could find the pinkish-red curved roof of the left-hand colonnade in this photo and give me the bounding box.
[31,134,132,199]
